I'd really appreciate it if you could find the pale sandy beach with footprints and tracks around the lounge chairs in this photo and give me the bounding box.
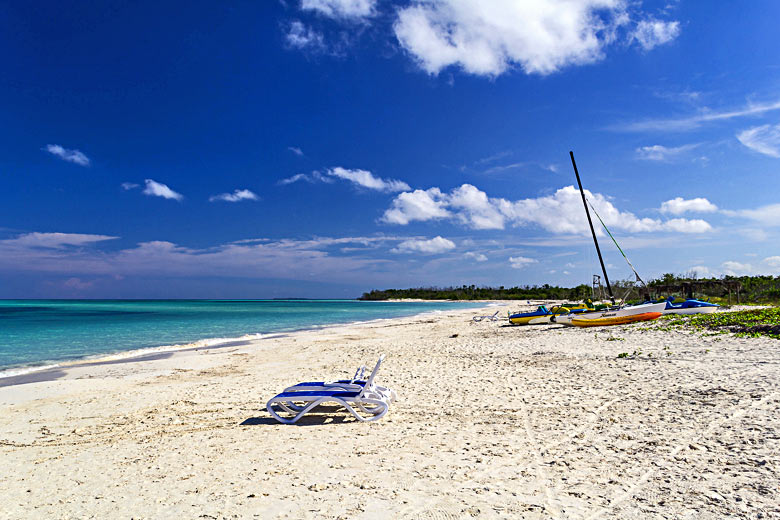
[0,305,780,519]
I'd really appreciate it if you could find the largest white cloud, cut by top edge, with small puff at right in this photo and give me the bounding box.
[393,0,679,76]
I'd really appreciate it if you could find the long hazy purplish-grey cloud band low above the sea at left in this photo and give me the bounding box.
[0,233,408,285]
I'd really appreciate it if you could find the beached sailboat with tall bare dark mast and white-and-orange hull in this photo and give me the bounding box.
[551,151,666,327]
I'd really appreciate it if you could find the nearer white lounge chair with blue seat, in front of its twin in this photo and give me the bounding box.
[266,355,390,424]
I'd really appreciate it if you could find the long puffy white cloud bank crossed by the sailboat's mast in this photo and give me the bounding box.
[382,184,711,234]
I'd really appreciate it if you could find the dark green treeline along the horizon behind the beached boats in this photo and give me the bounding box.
[358,273,780,303]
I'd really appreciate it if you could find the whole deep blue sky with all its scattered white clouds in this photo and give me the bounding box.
[0,0,780,298]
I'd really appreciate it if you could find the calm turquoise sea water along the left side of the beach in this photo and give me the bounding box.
[0,300,476,373]
